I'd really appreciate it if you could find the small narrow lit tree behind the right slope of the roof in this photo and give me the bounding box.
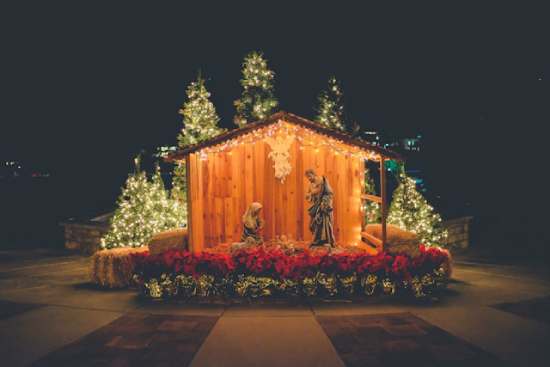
[316,77,346,131]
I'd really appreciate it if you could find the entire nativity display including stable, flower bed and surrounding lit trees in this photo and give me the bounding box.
[92,53,451,299]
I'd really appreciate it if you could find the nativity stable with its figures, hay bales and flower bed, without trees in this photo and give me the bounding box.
[92,111,451,299]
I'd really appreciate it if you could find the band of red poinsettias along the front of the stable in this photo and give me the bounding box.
[132,245,450,280]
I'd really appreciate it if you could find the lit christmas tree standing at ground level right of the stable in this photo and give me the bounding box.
[388,173,447,246]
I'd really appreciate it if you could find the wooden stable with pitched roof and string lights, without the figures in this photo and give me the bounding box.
[169,111,400,252]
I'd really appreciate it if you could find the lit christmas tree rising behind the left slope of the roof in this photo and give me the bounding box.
[178,75,224,148]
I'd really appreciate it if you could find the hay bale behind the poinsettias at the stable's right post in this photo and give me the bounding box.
[364,224,420,257]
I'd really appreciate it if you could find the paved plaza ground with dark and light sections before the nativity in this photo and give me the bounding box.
[0,252,550,367]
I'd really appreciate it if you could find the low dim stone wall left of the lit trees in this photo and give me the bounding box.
[61,221,109,255]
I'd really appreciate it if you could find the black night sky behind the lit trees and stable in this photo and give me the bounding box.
[0,2,550,260]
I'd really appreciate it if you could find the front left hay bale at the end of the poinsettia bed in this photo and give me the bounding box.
[90,246,149,288]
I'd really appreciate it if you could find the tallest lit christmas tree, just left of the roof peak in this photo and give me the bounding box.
[234,51,278,127]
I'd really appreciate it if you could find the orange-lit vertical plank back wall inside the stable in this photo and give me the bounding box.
[189,123,364,251]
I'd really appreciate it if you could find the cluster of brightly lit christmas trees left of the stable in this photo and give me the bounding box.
[101,158,186,248]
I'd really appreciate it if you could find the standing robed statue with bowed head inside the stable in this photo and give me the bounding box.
[306,169,336,246]
